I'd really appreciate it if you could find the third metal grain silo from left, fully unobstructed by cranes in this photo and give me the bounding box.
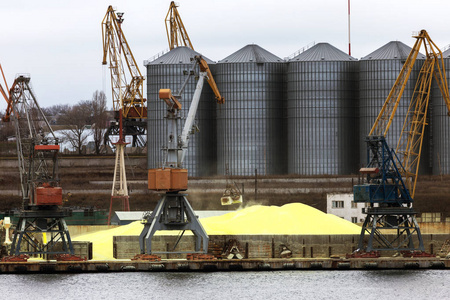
[287,43,358,175]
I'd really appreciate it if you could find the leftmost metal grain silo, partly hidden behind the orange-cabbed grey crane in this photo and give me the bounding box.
[145,47,216,176]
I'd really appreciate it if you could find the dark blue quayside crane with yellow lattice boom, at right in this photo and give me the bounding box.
[353,30,450,252]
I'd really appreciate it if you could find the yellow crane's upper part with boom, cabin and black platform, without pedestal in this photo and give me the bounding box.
[102,6,147,147]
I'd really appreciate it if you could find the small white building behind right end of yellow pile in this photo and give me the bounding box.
[327,194,366,223]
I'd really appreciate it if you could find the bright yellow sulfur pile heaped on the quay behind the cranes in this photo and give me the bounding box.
[74,203,361,260]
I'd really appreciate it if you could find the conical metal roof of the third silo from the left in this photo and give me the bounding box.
[289,43,357,61]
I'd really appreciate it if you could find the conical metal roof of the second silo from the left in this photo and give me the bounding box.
[219,44,283,63]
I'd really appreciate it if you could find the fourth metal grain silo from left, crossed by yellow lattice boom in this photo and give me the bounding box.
[359,41,430,173]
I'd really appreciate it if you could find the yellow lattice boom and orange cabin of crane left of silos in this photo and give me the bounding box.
[102,6,147,119]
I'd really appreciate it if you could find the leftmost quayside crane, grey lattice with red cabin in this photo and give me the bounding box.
[0,67,74,260]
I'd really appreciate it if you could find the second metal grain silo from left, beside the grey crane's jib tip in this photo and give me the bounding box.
[215,45,286,175]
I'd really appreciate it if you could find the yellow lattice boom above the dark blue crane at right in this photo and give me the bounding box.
[369,30,450,198]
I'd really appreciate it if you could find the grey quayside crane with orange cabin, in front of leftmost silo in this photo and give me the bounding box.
[139,56,225,254]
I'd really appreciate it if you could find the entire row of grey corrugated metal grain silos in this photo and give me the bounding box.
[146,41,450,176]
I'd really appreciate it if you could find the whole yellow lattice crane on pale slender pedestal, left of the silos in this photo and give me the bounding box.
[102,6,143,224]
